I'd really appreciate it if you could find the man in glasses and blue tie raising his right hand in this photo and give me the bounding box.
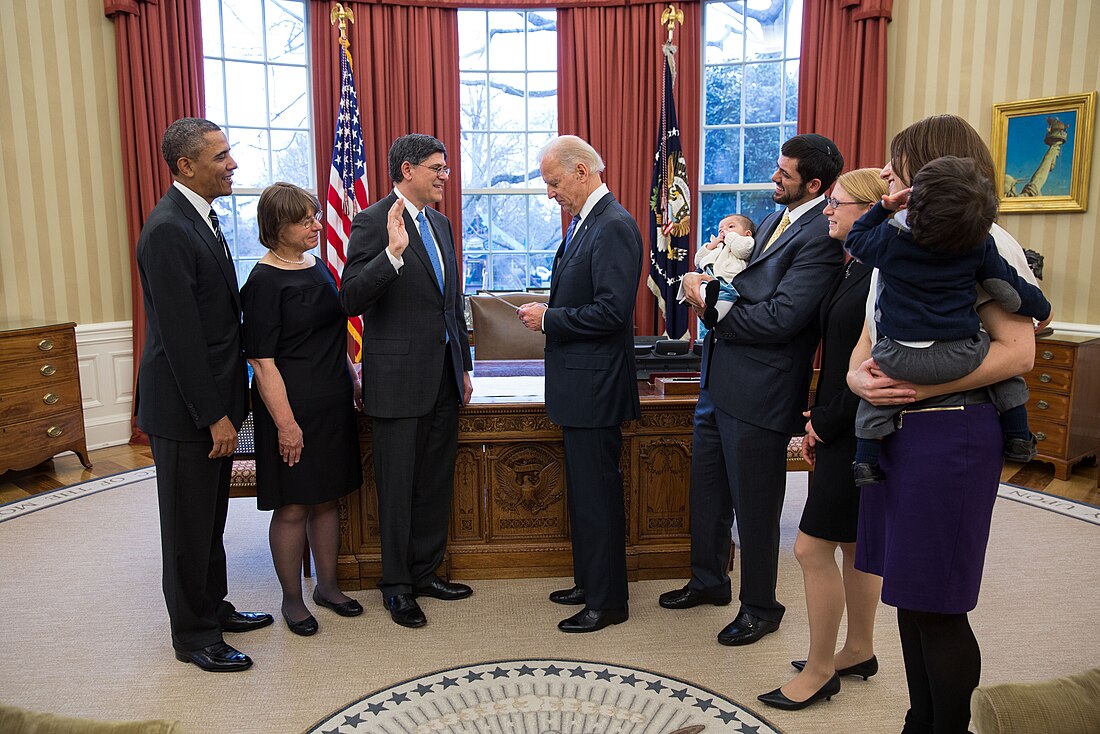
[340,134,473,627]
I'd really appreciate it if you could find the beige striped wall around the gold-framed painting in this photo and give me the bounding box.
[887,0,1100,325]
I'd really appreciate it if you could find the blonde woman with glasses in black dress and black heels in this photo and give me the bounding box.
[760,168,887,709]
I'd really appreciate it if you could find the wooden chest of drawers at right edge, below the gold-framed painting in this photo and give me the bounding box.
[1024,332,1100,480]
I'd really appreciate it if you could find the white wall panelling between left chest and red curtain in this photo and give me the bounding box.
[76,321,134,450]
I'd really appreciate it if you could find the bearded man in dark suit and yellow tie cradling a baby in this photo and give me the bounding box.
[660,134,844,645]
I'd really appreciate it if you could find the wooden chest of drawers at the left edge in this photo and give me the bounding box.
[0,322,91,473]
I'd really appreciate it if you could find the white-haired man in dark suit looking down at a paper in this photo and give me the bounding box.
[518,135,641,632]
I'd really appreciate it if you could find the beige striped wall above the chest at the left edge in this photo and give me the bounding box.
[0,0,130,324]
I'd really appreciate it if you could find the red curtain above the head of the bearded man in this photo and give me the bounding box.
[799,0,893,171]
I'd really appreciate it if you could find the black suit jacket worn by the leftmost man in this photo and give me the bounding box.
[135,185,248,441]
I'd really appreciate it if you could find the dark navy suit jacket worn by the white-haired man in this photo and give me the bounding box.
[542,194,641,428]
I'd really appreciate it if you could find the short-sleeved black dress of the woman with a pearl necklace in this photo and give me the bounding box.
[241,259,363,510]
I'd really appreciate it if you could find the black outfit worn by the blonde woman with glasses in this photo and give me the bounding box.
[799,260,871,543]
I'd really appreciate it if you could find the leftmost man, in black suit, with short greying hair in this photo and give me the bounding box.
[135,118,272,671]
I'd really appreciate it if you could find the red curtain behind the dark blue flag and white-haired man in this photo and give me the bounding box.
[558,0,703,333]
